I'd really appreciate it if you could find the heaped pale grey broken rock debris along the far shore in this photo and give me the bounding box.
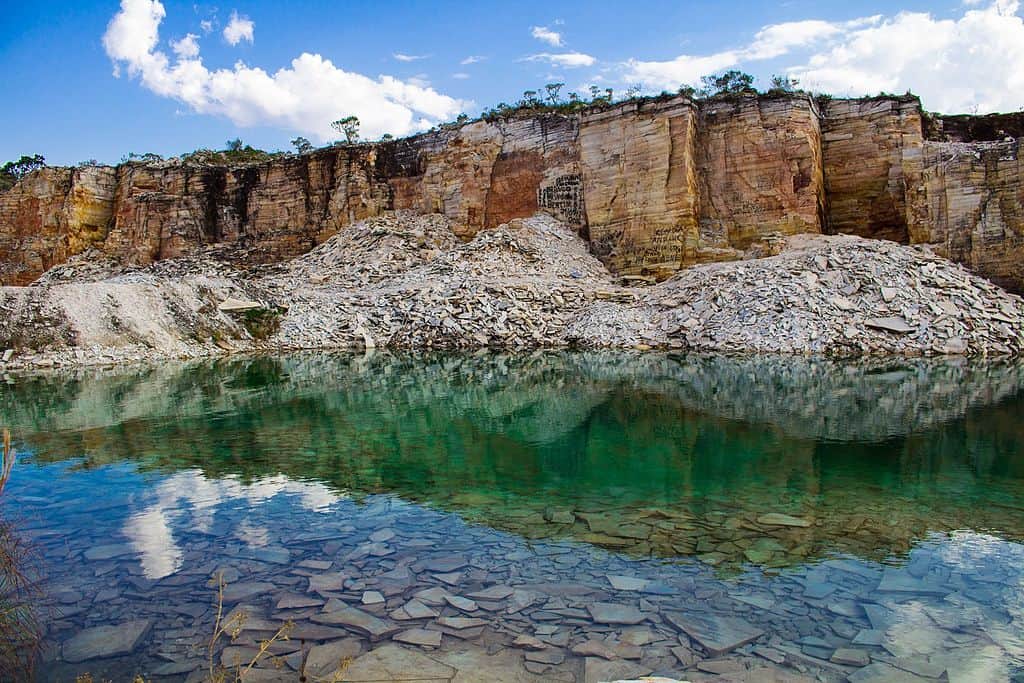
[0,212,1024,365]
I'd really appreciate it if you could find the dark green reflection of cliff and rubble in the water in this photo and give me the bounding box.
[0,353,1024,565]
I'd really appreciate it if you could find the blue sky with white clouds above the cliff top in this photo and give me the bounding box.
[0,0,1024,164]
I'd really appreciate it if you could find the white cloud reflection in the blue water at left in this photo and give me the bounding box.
[123,470,340,579]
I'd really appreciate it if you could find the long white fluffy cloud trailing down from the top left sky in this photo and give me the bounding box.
[103,0,470,141]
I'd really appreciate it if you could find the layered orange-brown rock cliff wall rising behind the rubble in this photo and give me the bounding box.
[0,94,1024,291]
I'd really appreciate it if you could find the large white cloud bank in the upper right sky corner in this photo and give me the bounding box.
[623,0,1024,113]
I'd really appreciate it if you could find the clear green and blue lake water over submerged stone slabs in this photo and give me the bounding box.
[0,352,1024,681]
